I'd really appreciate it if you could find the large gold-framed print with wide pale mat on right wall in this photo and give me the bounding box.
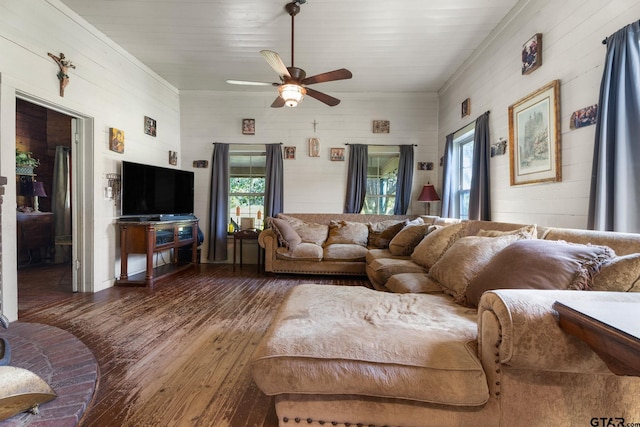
[509,80,562,185]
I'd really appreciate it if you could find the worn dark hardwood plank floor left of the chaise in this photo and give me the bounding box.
[18,264,370,427]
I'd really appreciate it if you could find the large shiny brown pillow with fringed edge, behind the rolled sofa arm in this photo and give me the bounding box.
[466,239,615,306]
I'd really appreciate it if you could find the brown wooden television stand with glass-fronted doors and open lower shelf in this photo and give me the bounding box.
[116,217,198,287]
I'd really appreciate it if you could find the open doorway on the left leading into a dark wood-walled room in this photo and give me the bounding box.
[16,96,93,311]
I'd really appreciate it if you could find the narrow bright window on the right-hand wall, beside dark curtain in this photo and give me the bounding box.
[452,124,475,219]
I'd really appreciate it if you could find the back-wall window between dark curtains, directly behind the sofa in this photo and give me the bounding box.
[362,147,400,215]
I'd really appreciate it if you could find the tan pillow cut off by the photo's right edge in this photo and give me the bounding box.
[591,253,640,292]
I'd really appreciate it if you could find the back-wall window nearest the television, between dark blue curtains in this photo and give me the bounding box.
[229,150,267,229]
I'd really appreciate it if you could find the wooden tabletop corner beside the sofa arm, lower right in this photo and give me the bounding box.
[553,301,640,376]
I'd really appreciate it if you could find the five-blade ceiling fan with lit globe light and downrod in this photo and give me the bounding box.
[227,0,353,108]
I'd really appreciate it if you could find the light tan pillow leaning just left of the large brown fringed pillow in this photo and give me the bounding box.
[429,234,524,304]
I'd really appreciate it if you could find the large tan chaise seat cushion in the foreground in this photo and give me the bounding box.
[251,285,489,406]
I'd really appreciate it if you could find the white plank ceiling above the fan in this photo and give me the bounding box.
[61,0,517,93]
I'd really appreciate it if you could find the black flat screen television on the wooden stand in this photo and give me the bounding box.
[120,161,194,220]
